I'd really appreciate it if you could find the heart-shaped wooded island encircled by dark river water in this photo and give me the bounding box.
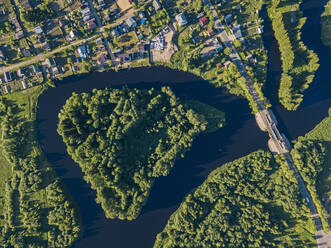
[58,87,224,220]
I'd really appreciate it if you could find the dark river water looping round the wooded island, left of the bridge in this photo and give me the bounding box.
[36,67,267,248]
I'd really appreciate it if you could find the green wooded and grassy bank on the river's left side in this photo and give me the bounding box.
[0,87,80,248]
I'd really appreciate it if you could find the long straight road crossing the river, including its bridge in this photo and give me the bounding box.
[207,0,327,248]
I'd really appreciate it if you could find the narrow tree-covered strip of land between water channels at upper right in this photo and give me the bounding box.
[268,0,319,110]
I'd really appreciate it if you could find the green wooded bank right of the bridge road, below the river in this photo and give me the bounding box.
[291,108,331,230]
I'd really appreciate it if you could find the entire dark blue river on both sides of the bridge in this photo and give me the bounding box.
[36,0,331,248]
